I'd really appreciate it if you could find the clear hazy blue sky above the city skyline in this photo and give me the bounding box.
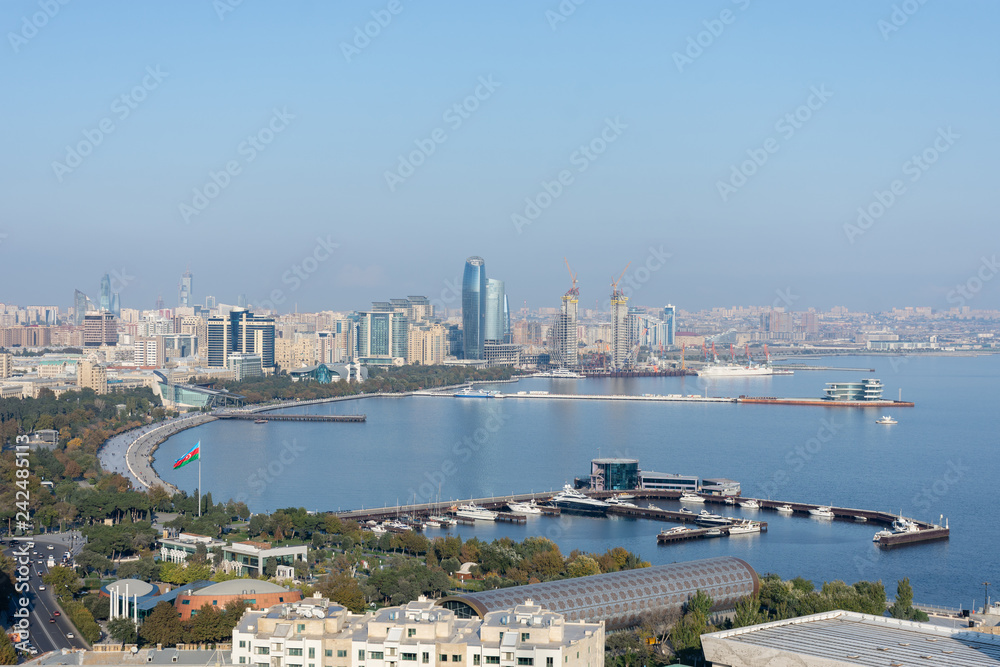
[0,0,1000,310]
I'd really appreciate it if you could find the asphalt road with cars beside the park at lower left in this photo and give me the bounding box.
[3,533,88,654]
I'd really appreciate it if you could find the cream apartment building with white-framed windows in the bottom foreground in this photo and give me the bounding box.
[232,597,604,667]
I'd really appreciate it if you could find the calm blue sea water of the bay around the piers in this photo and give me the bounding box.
[156,356,1000,608]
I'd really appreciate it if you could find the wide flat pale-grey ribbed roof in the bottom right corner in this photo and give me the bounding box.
[701,611,1000,667]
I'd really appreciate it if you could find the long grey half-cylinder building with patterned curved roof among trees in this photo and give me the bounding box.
[438,556,760,630]
